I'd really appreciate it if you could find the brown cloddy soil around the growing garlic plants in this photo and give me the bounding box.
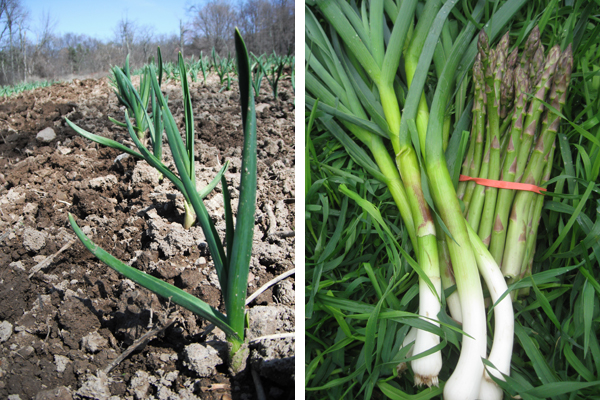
[0,72,295,400]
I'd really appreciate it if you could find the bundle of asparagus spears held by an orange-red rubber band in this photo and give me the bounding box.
[457,27,573,296]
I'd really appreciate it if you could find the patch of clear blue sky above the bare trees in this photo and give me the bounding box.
[22,0,202,41]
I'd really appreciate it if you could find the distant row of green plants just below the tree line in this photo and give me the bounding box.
[132,49,295,100]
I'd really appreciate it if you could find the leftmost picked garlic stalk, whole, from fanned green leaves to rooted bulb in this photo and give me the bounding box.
[319,0,441,386]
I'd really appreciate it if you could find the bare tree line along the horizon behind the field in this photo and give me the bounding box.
[0,0,294,85]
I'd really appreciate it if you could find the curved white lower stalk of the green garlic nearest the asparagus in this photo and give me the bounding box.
[468,226,515,400]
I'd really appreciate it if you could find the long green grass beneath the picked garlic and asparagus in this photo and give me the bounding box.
[305,1,600,400]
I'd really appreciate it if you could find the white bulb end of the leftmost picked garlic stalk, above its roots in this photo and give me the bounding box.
[411,274,442,387]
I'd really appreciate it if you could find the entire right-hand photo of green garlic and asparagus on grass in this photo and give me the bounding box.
[305,0,600,400]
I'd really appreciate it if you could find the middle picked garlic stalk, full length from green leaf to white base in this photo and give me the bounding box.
[424,5,486,400]
